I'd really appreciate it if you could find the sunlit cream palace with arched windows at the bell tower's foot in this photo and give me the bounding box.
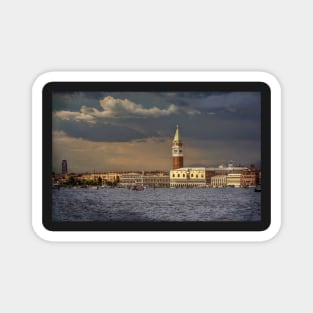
[170,167,207,188]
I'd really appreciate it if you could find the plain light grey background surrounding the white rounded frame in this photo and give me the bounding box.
[0,0,313,313]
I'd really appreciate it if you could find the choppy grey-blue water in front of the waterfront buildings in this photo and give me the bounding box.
[52,188,261,221]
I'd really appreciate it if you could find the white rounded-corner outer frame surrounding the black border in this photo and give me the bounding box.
[32,71,281,242]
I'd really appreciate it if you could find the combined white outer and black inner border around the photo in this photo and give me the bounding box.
[33,72,281,241]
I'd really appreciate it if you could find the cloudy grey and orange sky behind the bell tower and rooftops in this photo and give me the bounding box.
[53,92,261,172]
